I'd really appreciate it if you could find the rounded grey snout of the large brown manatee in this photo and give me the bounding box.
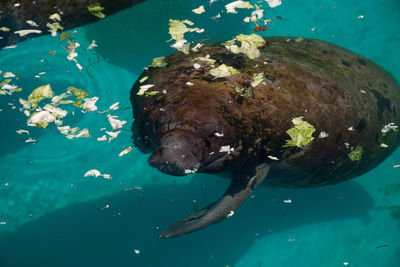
[149,133,200,176]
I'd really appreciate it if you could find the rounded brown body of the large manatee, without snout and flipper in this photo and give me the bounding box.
[131,37,400,187]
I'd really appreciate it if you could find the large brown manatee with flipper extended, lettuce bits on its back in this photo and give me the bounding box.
[131,37,400,238]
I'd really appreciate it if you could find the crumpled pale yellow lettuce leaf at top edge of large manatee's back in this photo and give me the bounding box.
[223,33,265,59]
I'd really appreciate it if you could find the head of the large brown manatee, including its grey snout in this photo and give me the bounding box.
[133,89,236,176]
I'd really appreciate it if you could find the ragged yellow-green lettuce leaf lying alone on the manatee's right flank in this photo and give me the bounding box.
[283,117,315,148]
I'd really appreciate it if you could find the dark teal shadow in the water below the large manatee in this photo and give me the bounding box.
[0,176,373,267]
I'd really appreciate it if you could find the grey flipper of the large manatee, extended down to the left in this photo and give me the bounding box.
[159,164,270,238]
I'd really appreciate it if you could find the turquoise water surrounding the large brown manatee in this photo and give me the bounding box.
[0,0,400,267]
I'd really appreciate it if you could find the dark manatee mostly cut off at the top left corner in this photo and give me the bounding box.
[0,0,145,49]
